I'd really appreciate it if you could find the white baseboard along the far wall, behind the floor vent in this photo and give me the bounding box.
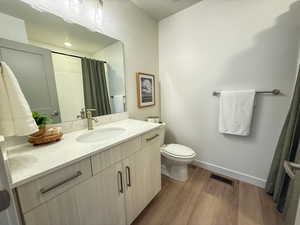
[193,160,266,188]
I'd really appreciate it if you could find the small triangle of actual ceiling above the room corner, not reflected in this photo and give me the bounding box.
[131,0,201,20]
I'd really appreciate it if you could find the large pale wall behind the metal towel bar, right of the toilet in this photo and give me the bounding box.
[159,0,300,186]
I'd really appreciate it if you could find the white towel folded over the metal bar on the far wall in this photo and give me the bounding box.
[219,90,255,136]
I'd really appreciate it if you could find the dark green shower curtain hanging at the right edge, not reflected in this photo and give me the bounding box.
[266,67,300,225]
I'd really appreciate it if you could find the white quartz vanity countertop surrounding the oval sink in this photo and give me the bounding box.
[6,119,162,188]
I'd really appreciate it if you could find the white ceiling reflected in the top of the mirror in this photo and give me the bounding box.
[0,0,117,54]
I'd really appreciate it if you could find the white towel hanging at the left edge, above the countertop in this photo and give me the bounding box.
[0,61,38,137]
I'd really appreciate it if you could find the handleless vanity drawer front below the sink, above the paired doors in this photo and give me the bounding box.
[92,137,141,175]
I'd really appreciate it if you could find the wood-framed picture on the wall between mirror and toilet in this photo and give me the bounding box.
[136,72,155,108]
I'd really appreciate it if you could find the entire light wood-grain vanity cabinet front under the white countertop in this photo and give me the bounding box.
[17,126,161,225]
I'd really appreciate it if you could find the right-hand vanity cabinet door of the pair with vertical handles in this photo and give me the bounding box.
[123,151,147,224]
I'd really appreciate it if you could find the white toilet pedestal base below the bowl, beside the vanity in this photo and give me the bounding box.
[161,156,189,182]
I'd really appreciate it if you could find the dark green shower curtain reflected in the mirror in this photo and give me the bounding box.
[81,58,111,116]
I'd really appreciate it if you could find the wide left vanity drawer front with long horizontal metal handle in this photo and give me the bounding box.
[17,159,92,213]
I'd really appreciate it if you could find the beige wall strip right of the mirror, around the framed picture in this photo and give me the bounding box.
[103,0,160,119]
